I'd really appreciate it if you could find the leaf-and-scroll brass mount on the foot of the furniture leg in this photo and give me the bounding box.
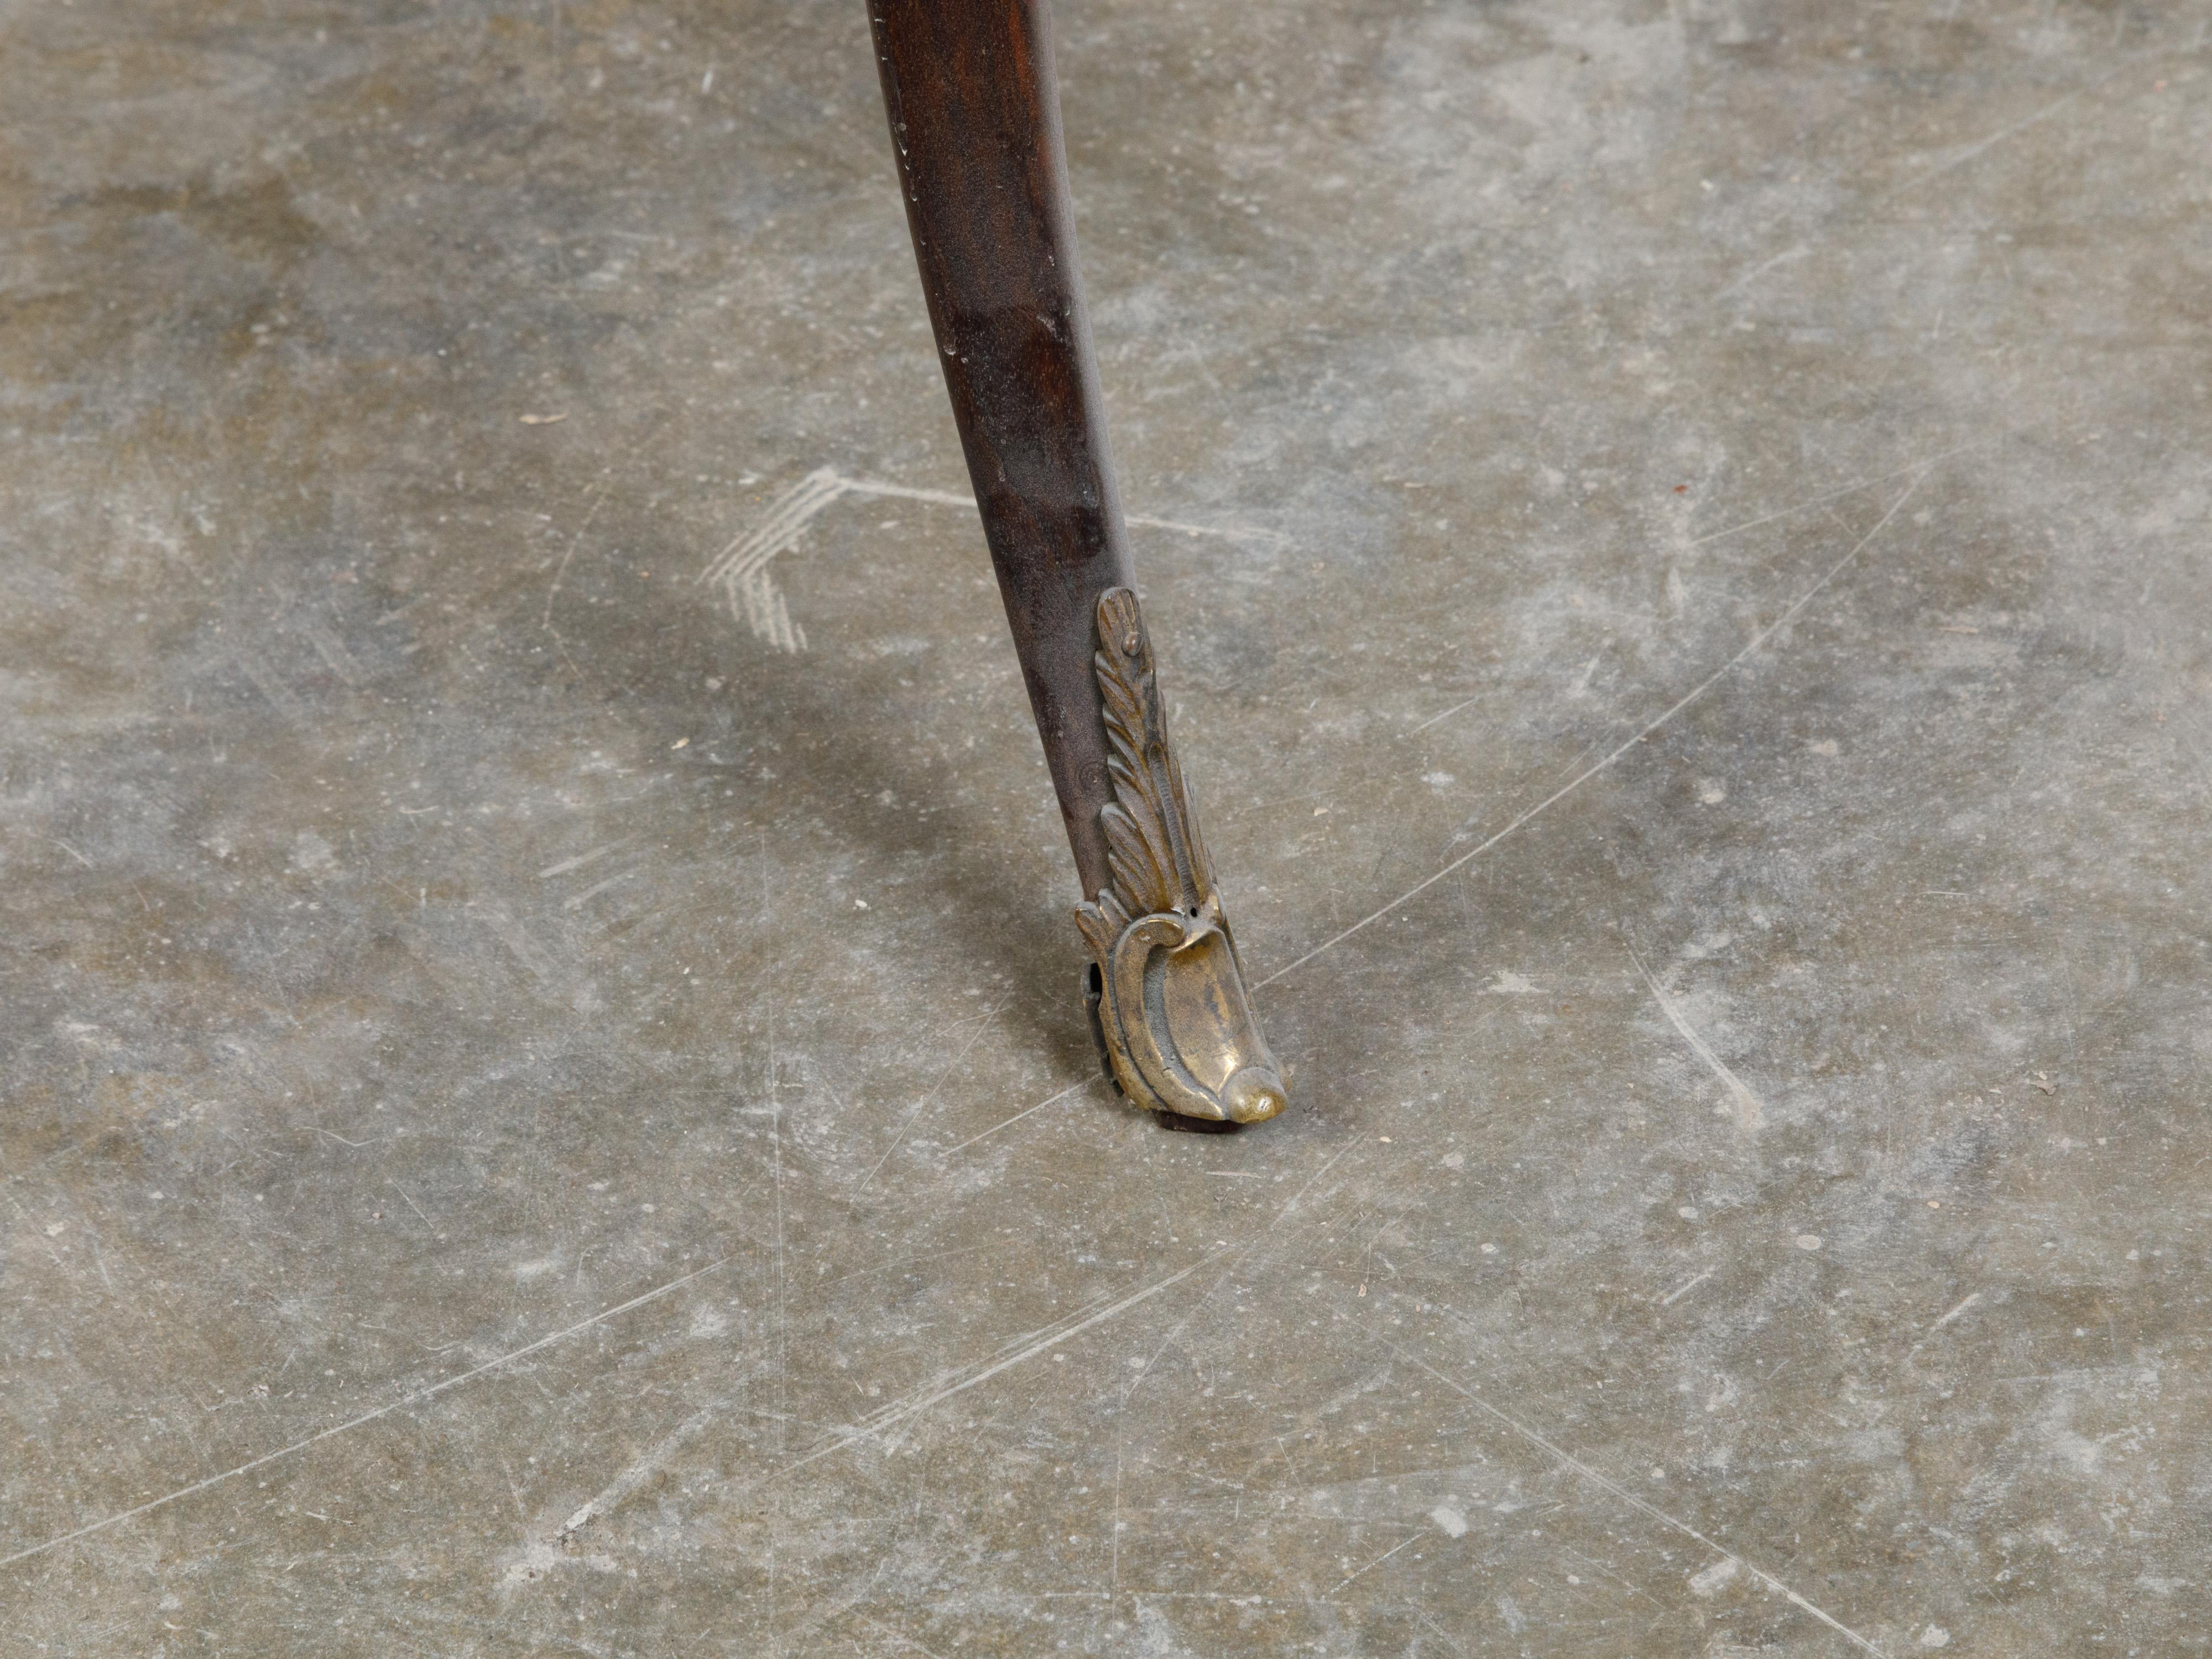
[1075,588,1290,1124]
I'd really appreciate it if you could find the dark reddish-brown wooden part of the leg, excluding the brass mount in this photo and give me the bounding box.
[869,0,1135,896]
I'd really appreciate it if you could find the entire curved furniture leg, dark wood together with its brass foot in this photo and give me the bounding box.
[869,0,1285,1124]
